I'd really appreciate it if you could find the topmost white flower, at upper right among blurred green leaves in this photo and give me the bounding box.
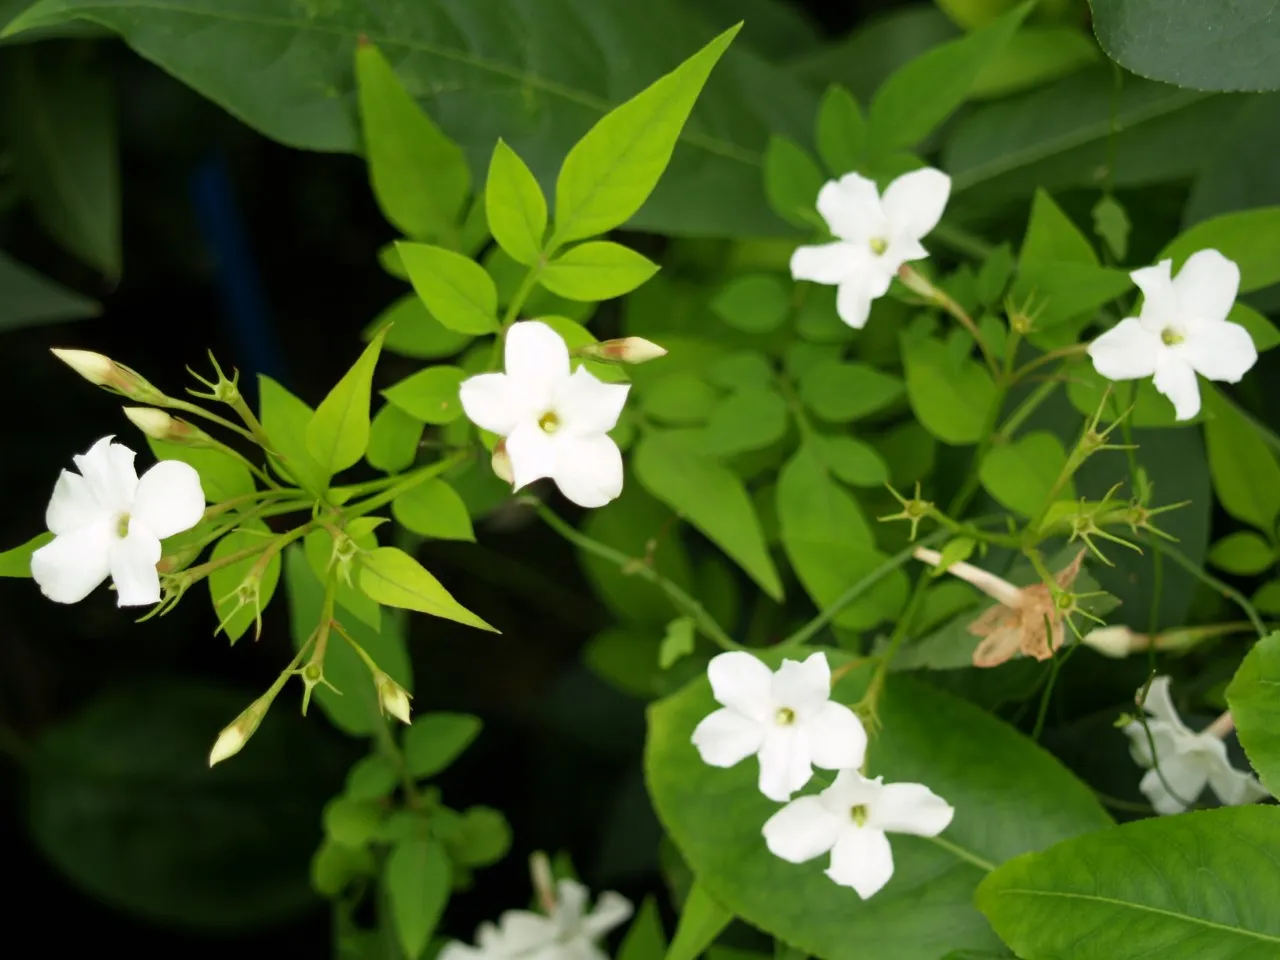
[791,168,951,328]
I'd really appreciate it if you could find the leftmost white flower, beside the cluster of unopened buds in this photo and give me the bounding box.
[31,436,205,607]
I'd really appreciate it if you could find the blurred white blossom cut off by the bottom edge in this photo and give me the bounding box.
[439,879,631,960]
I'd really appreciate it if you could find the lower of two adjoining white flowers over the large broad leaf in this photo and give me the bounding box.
[764,771,955,900]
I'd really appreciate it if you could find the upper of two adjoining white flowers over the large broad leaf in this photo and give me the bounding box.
[694,650,867,801]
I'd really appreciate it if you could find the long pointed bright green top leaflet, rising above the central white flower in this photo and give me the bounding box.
[552,27,739,246]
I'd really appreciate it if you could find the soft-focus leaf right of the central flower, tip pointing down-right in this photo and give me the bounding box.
[631,430,782,600]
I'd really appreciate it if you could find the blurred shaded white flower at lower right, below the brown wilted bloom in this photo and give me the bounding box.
[1124,677,1268,814]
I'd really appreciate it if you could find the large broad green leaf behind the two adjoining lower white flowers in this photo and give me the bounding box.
[645,649,1110,960]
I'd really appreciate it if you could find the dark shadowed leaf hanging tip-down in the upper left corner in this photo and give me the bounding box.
[0,44,120,276]
